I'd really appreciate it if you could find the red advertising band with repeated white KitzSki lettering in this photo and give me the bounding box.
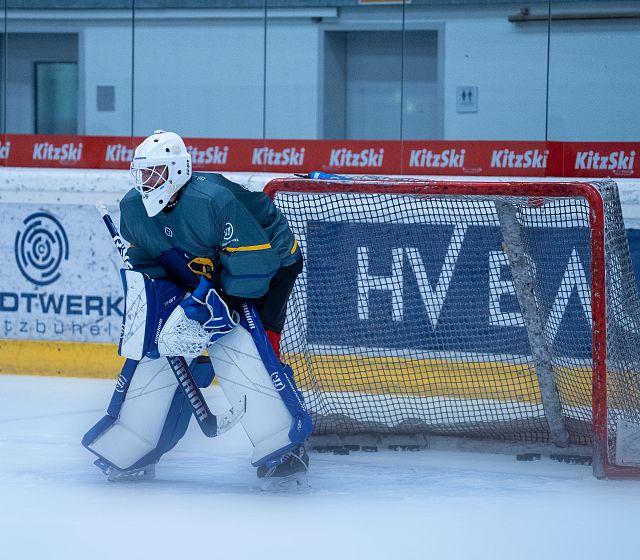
[0,134,640,178]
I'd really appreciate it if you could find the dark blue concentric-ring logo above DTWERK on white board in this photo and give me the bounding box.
[15,212,69,286]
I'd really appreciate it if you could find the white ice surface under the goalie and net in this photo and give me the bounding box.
[0,375,640,560]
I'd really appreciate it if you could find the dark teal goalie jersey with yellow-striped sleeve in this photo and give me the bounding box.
[120,173,301,298]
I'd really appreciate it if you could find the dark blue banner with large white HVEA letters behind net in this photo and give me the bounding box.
[306,221,591,357]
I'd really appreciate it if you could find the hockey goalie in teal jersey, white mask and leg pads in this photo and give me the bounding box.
[82,131,312,487]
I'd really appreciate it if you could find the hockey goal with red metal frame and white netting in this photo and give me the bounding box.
[266,178,640,477]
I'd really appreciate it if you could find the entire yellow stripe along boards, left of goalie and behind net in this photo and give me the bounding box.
[0,340,592,407]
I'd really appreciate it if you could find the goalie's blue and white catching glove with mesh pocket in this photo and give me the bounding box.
[158,276,239,357]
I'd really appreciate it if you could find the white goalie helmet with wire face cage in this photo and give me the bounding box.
[131,130,191,217]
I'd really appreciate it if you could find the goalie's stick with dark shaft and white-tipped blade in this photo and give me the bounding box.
[96,203,247,437]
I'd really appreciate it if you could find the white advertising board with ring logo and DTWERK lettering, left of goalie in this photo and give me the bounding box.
[0,202,123,342]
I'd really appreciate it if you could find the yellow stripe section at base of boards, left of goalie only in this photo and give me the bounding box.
[0,340,125,379]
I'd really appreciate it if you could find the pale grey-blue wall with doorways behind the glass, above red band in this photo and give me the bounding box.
[1,1,640,141]
